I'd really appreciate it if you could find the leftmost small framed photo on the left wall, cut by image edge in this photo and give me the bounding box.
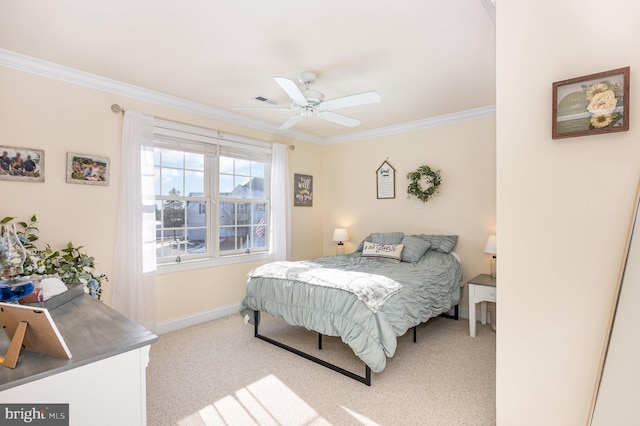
[0,145,44,182]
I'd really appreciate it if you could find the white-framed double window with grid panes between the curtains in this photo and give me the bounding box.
[154,120,271,264]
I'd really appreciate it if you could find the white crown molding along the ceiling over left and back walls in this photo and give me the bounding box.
[0,49,496,144]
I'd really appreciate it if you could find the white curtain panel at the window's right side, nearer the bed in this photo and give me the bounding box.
[270,143,291,261]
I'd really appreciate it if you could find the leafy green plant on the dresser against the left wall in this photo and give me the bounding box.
[0,215,108,300]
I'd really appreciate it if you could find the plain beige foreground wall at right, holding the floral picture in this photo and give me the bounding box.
[497,0,640,426]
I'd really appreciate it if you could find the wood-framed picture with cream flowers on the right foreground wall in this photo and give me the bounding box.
[551,67,629,139]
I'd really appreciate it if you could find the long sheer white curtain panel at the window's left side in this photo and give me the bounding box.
[112,110,156,331]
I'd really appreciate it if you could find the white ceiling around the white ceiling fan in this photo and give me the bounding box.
[0,0,495,144]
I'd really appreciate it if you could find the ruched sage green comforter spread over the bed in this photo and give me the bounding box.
[240,246,463,372]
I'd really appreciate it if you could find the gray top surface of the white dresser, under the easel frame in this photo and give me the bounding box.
[0,294,158,391]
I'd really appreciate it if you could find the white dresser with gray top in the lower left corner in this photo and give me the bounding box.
[0,295,158,426]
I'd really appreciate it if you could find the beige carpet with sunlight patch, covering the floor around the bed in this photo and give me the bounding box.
[147,314,496,426]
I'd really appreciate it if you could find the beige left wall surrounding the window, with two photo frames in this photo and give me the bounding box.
[0,67,323,323]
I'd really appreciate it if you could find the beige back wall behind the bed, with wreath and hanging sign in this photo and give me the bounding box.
[322,117,496,308]
